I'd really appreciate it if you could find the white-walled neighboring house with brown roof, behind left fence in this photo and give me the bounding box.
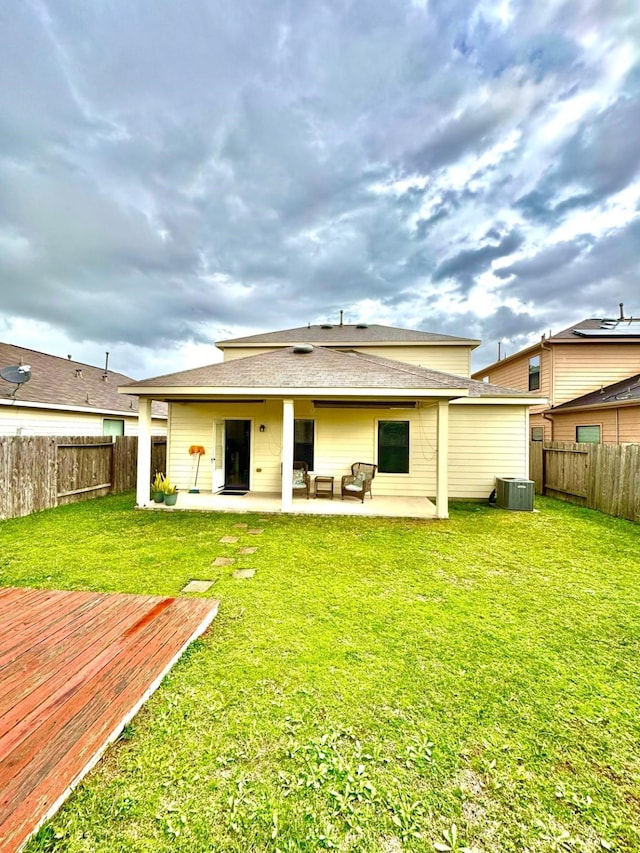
[0,343,167,435]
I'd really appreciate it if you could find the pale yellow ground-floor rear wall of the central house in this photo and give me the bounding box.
[167,400,528,498]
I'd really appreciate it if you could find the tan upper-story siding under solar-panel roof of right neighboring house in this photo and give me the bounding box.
[549,343,640,406]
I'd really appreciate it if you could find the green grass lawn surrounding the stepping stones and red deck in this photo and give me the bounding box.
[0,495,640,853]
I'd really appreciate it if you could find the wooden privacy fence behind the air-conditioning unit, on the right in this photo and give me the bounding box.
[529,441,640,521]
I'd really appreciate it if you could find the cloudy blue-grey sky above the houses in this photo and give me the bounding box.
[0,0,640,378]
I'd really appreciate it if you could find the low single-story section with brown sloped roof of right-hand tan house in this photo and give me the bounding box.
[547,374,640,444]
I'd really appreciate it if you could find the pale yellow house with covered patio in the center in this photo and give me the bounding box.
[120,324,544,518]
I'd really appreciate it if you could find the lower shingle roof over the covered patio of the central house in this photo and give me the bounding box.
[121,347,541,402]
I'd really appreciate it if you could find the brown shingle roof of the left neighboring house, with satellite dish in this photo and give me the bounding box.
[0,343,167,417]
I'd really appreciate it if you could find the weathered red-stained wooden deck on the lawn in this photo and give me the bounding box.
[0,589,218,853]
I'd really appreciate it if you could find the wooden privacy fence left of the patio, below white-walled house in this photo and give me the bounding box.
[0,435,167,519]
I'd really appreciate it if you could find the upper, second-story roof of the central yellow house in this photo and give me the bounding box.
[216,323,480,349]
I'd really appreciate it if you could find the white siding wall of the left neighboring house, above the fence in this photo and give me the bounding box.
[0,406,167,435]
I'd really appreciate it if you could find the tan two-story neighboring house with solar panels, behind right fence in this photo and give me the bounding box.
[472,312,640,442]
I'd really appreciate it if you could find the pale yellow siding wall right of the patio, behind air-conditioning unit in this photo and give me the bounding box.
[449,403,529,498]
